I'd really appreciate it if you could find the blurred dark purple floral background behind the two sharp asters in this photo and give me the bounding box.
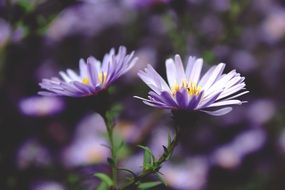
[0,0,285,190]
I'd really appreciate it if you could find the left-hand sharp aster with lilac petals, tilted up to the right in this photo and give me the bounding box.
[39,46,137,97]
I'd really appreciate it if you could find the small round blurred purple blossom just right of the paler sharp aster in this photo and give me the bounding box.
[247,99,276,124]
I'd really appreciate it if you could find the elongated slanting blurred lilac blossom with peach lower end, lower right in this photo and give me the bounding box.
[212,129,266,169]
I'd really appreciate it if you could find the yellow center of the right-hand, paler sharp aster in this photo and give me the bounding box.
[171,81,202,96]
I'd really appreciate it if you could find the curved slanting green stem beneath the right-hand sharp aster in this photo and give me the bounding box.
[119,127,179,190]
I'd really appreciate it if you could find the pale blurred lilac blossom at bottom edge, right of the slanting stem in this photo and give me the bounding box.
[160,157,209,190]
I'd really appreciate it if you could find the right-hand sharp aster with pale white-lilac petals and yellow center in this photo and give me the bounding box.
[136,55,248,116]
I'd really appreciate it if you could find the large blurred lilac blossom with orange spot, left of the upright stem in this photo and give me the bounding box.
[62,113,109,167]
